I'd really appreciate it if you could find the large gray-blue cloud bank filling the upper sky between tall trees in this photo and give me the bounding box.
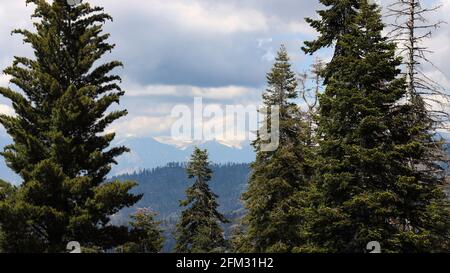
[92,0,315,87]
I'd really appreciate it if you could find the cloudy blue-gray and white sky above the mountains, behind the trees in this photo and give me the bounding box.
[0,0,450,143]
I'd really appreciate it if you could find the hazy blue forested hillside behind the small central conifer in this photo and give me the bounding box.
[113,163,251,252]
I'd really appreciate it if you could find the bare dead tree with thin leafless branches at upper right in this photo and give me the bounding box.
[387,0,450,130]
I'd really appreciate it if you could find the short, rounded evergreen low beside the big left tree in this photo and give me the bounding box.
[123,209,164,253]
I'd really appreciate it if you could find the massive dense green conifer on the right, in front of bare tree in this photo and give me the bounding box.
[307,0,450,252]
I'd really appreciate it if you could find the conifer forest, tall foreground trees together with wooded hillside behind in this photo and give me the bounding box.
[0,0,450,253]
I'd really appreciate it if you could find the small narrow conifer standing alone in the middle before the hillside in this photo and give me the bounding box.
[175,147,228,253]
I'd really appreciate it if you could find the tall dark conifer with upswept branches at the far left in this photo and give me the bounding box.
[0,0,141,252]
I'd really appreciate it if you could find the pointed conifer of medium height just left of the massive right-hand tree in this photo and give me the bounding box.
[239,46,312,252]
